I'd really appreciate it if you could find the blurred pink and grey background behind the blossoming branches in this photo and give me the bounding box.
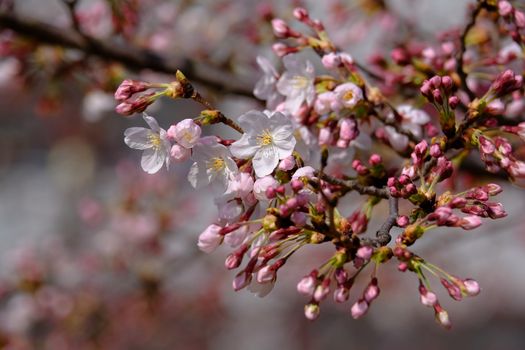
[0,0,525,350]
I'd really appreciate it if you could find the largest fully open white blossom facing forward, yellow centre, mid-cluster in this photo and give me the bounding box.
[230,110,296,177]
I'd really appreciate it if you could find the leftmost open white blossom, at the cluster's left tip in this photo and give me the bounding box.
[124,114,171,174]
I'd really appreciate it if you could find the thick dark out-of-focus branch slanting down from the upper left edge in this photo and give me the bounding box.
[0,13,253,98]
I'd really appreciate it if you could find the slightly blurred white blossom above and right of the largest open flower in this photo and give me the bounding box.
[277,54,315,114]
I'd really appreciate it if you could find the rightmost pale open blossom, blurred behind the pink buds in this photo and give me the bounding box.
[385,105,430,151]
